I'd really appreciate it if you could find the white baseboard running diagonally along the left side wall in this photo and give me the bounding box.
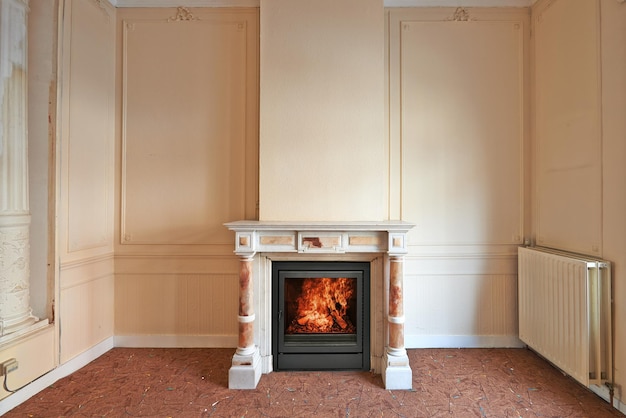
[0,337,114,416]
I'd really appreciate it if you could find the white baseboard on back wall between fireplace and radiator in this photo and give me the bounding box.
[404,335,526,349]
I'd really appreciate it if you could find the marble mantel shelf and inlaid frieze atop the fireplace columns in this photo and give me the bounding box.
[224,220,415,256]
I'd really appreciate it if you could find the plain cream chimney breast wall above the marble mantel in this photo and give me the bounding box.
[259,0,388,221]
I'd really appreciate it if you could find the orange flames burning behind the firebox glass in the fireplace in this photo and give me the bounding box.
[287,277,354,333]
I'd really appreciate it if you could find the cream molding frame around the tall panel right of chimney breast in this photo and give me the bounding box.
[389,8,529,246]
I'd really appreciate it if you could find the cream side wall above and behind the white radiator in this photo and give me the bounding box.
[533,0,626,411]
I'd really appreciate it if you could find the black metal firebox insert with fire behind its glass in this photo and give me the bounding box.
[272,261,370,371]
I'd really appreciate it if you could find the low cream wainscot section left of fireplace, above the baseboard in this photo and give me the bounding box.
[115,256,239,344]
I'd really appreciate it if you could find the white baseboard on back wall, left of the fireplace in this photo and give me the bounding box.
[114,335,238,349]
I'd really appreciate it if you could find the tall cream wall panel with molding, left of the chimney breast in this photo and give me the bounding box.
[119,6,258,247]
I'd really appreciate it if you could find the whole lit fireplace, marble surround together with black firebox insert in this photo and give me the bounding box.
[225,220,414,389]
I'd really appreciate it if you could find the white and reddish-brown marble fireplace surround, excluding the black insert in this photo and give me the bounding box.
[225,220,414,389]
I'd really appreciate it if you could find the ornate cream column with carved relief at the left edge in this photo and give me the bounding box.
[0,0,37,337]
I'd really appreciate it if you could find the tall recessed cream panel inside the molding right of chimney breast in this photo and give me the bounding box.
[398,14,525,245]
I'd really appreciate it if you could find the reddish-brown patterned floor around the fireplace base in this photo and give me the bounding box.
[5,348,624,418]
